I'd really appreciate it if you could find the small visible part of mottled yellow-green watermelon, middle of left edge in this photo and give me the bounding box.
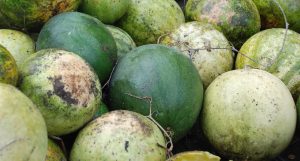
[0,45,18,86]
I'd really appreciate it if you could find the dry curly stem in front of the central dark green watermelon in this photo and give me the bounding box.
[125,93,174,157]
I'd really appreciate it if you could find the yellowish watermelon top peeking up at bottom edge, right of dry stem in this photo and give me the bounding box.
[167,151,221,161]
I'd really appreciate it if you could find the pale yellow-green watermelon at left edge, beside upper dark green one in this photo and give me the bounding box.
[0,29,35,68]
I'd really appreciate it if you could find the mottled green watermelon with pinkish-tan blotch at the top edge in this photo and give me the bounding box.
[185,0,261,48]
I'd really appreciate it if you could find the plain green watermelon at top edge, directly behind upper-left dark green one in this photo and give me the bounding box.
[80,0,131,24]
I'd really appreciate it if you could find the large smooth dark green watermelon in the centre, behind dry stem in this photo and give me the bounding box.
[109,45,203,141]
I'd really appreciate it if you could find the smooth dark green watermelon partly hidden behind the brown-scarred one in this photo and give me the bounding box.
[36,12,117,84]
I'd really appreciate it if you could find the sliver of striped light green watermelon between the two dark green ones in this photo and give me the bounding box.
[106,25,136,59]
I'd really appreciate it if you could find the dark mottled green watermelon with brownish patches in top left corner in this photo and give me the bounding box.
[0,0,81,30]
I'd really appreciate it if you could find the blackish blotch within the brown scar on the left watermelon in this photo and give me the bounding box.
[48,76,78,105]
